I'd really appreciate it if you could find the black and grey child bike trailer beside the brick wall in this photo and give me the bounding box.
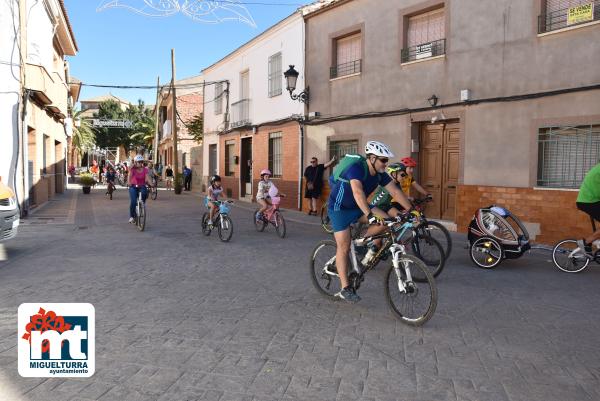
[468,205,531,269]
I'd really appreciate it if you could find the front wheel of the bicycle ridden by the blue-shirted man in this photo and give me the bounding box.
[384,255,437,326]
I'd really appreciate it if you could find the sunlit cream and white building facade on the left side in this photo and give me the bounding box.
[18,0,78,210]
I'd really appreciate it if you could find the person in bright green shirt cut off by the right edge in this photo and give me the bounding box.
[577,163,600,259]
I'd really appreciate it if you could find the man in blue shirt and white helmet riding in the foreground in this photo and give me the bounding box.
[327,141,411,302]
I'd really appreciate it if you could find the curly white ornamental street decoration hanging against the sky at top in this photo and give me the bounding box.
[96,0,256,28]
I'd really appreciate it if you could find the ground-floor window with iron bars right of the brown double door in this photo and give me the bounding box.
[537,124,600,189]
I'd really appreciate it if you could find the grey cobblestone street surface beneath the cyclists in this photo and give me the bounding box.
[0,188,600,401]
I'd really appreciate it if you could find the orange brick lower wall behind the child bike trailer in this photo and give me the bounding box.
[456,185,592,245]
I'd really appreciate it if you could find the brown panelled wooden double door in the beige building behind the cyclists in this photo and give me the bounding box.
[419,123,460,221]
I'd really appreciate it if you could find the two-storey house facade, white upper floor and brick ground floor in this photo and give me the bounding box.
[203,13,304,208]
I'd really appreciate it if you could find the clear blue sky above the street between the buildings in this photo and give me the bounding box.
[65,0,311,104]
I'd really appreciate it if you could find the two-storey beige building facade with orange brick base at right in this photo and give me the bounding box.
[305,0,600,242]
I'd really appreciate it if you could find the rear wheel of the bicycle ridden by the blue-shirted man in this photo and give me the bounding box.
[309,241,342,298]
